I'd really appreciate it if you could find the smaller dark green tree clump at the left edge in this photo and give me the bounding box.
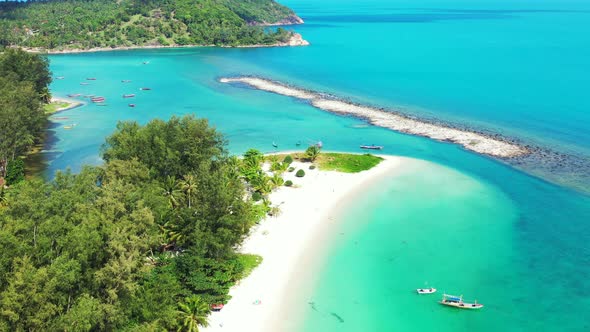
[0,49,51,180]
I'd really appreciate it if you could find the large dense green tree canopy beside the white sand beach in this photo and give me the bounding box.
[0,116,268,331]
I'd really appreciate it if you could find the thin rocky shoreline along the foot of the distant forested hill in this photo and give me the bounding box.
[18,33,310,55]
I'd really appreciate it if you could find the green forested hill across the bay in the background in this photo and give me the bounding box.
[0,0,302,50]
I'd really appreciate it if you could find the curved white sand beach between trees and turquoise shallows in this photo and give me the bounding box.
[201,156,412,332]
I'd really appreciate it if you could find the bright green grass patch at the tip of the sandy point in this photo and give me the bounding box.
[278,152,383,173]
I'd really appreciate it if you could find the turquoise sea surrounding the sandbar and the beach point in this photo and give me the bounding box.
[44,0,590,332]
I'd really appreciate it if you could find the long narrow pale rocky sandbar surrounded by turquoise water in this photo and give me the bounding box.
[219,76,530,158]
